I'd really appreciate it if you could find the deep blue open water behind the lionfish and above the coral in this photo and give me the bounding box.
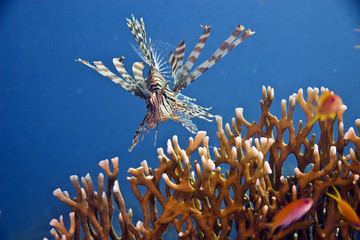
[0,0,360,239]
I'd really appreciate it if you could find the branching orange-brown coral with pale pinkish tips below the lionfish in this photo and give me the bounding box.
[44,87,360,239]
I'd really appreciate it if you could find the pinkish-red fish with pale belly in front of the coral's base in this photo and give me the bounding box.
[267,198,314,235]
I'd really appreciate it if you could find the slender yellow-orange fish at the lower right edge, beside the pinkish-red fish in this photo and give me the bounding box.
[326,186,360,230]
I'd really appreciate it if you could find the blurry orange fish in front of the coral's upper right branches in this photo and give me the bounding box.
[306,91,342,126]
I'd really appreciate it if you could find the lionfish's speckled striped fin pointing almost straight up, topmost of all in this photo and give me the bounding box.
[126,15,153,66]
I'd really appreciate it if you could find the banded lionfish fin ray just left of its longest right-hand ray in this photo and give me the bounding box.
[175,25,211,83]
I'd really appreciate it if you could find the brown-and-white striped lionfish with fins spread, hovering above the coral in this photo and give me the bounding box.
[77,16,255,151]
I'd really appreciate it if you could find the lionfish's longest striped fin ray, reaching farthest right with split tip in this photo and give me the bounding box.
[174,25,255,92]
